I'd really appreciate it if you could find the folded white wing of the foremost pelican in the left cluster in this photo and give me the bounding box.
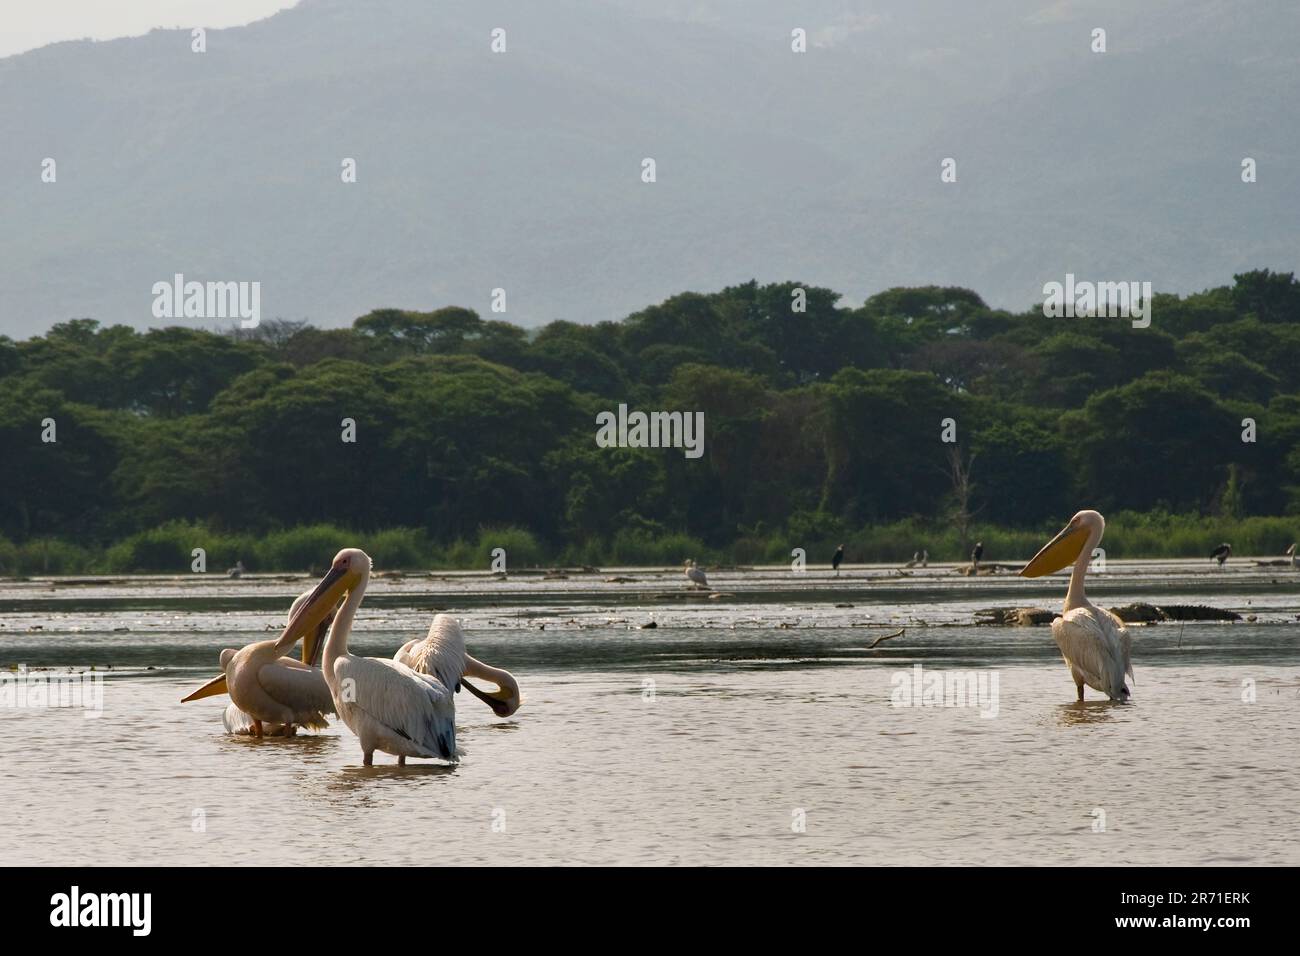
[334,654,456,760]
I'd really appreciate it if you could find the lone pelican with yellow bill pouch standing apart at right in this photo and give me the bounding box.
[1021,511,1134,701]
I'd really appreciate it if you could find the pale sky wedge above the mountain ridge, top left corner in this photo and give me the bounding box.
[0,0,298,56]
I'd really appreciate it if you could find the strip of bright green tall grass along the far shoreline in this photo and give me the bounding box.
[0,511,1300,575]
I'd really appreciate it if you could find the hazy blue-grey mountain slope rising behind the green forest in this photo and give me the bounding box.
[0,0,1300,336]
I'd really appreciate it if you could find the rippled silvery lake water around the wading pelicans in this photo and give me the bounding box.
[0,564,1300,865]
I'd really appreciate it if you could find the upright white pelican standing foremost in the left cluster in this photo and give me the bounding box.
[281,548,517,766]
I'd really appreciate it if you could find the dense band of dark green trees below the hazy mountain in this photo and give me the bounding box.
[0,271,1300,572]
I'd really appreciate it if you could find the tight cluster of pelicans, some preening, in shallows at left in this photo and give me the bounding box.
[182,548,523,766]
